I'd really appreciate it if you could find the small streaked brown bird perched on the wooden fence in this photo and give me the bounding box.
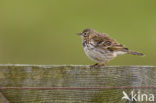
[79,28,144,67]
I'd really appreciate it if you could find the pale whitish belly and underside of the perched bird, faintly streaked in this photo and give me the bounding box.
[84,46,125,63]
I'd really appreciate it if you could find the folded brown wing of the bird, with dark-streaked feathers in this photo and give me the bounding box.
[93,33,127,51]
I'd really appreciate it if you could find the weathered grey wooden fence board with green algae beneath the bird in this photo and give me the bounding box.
[0,65,156,103]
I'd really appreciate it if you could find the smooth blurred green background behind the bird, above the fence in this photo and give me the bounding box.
[0,0,156,65]
